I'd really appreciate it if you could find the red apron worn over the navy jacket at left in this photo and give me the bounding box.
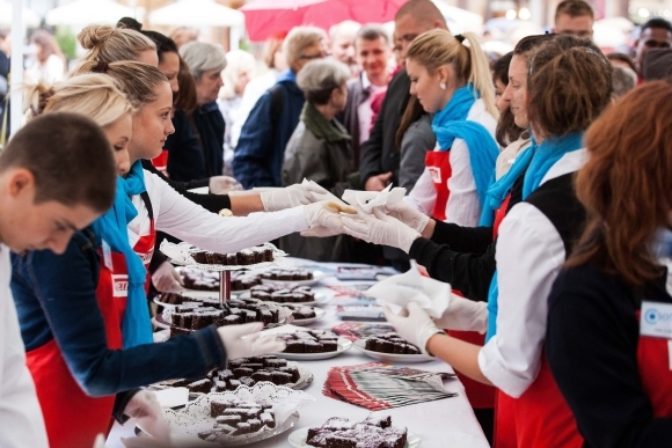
[26,192,156,448]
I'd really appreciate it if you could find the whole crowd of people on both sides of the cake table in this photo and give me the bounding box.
[0,0,672,448]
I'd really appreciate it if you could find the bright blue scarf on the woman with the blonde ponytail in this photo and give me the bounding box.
[432,84,499,204]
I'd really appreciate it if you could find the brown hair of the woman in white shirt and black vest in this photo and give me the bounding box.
[527,35,612,137]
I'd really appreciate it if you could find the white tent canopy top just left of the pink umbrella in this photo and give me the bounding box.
[149,0,245,27]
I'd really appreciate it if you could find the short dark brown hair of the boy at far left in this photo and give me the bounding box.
[0,112,116,213]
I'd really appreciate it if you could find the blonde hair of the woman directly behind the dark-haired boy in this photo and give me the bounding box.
[31,73,134,127]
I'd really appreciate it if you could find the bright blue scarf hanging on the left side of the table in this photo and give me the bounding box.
[93,161,152,348]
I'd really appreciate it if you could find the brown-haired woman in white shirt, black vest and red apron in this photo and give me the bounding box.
[343,36,611,447]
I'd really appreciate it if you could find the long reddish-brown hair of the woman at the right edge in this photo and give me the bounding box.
[567,81,672,286]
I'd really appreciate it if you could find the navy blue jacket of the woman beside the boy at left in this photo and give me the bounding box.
[11,229,226,396]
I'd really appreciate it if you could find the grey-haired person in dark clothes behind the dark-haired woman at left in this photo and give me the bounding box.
[176,42,226,181]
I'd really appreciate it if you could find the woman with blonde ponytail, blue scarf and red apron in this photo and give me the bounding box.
[406,30,499,226]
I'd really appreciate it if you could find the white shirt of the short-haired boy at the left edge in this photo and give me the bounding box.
[0,245,48,448]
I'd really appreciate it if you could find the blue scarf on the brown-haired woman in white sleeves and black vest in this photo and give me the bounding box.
[482,132,583,341]
